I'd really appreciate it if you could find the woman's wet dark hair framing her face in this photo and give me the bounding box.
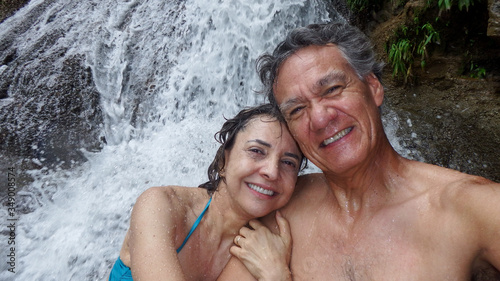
[199,103,306,195]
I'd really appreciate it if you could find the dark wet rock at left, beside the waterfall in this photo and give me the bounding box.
[0,0,103,173]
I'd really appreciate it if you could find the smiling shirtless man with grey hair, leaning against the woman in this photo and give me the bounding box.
[220,23,500,280]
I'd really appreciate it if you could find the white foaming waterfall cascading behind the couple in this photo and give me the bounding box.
[0,0,336,280]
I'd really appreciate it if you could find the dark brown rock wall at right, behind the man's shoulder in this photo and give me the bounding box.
[370,0,500,182]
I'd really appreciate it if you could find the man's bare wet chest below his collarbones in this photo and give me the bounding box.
[291,211,470,280]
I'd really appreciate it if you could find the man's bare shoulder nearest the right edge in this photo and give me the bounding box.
[419,161,500,244]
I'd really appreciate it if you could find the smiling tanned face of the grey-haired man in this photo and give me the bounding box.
[274,45,383,173]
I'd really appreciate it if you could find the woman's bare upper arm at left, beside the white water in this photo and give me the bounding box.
[129,187,186,281]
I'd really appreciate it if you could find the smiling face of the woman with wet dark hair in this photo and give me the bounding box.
[222,116,302,217]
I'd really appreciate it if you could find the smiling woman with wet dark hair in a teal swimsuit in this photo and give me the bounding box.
[110,104,303,281]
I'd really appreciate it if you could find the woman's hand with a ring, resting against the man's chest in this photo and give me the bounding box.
[229,211,292,281]
